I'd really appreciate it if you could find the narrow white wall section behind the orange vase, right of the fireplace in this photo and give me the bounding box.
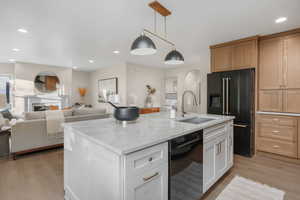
[71,71,92,104]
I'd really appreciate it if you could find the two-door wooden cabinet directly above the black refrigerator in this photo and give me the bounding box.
[210,37,258,72]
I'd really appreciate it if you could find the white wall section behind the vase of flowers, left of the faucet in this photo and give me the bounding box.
[127,63,164,107]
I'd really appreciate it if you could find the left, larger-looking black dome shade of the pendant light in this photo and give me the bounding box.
[130,34,156,56]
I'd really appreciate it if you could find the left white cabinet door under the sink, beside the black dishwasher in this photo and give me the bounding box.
[203,140,217,192]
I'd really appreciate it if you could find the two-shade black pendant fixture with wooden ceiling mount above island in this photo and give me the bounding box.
[130,1,184,65]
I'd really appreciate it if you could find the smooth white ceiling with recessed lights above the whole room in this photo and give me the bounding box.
[0,0,300,71]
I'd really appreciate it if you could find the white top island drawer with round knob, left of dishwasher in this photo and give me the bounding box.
[125,142,168,174]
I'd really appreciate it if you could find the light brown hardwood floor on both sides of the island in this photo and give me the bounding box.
[0,149,300,200]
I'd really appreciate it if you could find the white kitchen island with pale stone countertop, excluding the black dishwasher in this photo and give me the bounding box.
[64,113,234,200]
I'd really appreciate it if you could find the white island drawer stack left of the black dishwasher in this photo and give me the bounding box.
[125,143,168,200]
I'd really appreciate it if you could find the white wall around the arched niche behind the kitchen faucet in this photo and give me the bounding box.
[165,51,210,113]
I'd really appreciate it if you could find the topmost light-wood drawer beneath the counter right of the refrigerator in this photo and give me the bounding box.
[258,115,297,127]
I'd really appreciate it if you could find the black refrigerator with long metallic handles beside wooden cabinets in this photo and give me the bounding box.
[207,69,255,157]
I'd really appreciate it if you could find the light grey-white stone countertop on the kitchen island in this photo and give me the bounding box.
[64,112,234,155]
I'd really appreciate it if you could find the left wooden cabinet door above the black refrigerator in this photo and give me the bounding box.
[211,46,232,72]
